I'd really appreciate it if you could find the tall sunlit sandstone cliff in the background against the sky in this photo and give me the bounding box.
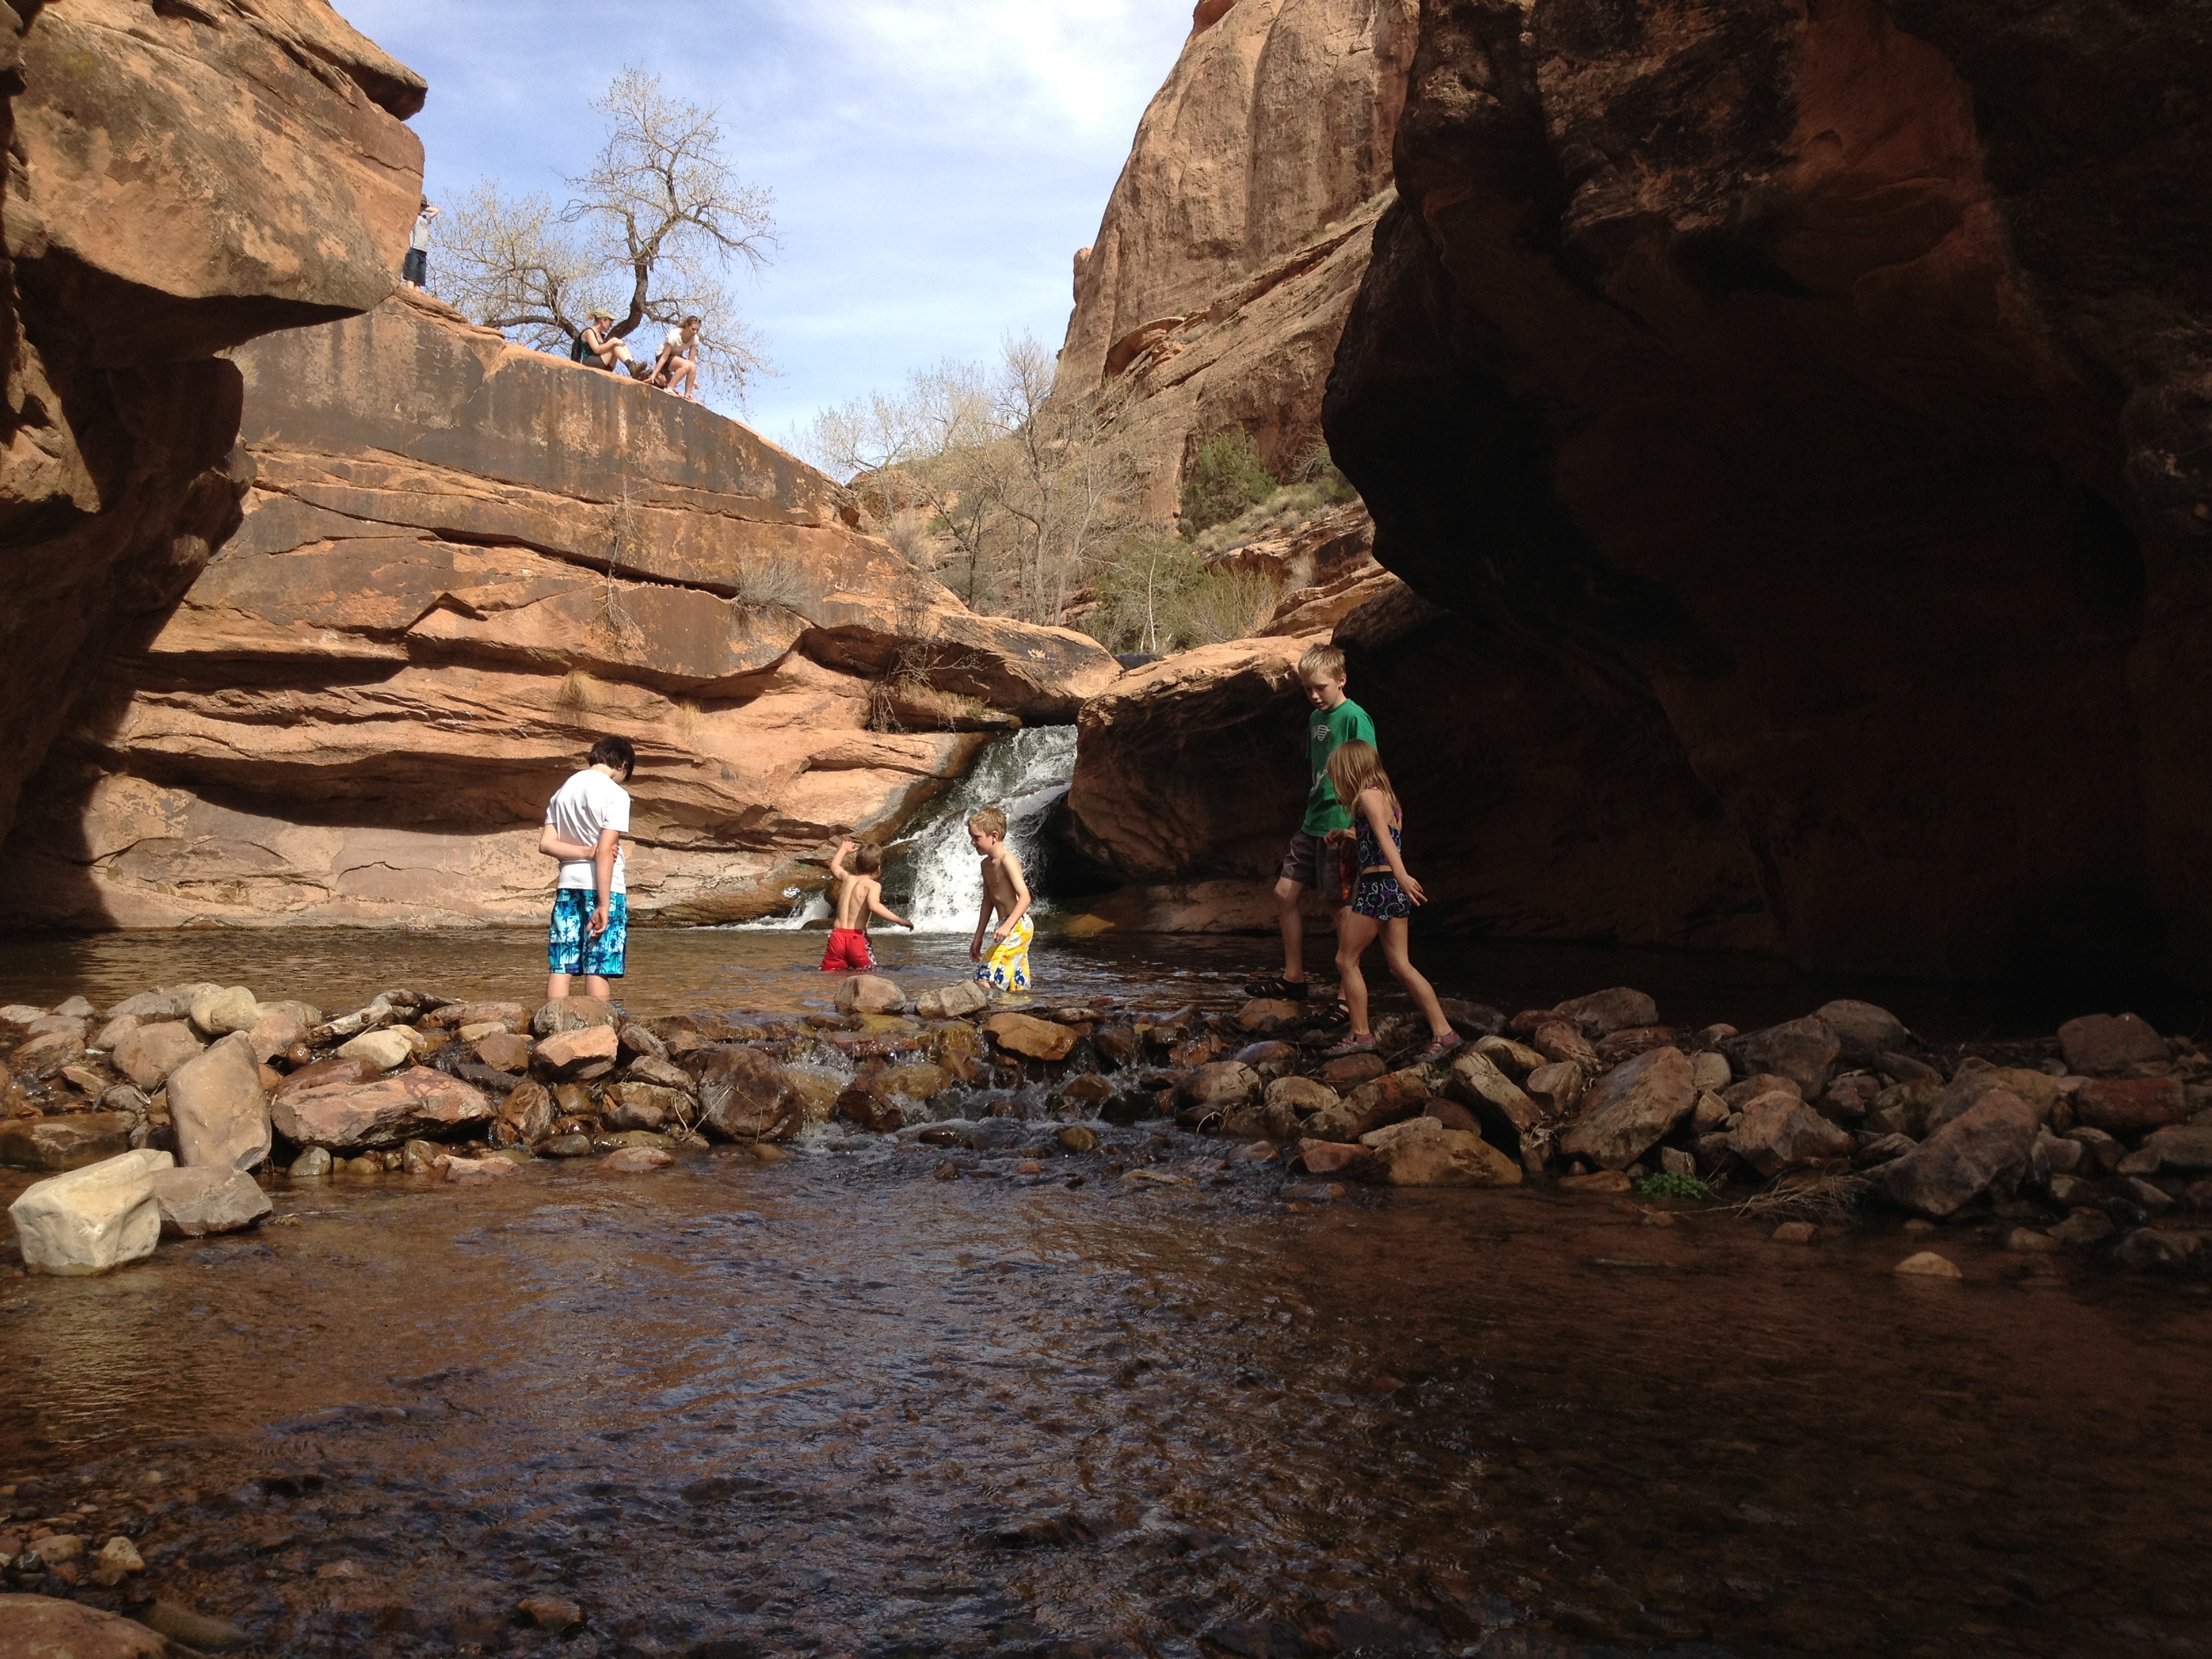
[1057,0,1416,518]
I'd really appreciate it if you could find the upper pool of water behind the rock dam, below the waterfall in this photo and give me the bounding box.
[0,927,2207,1042]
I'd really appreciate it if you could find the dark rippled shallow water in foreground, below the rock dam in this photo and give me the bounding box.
[0,1159,2212,1654]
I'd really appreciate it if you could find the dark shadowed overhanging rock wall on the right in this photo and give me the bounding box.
[1327,0,2212,975]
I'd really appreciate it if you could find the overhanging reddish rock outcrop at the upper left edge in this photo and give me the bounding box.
[0,0,425,849]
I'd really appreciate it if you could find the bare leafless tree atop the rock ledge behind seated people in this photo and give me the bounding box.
[436,68,777,398]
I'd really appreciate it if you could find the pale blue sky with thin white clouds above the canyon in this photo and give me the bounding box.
[338,0,1190,438]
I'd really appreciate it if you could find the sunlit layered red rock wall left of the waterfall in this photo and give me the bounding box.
[9,294,1117,927]
